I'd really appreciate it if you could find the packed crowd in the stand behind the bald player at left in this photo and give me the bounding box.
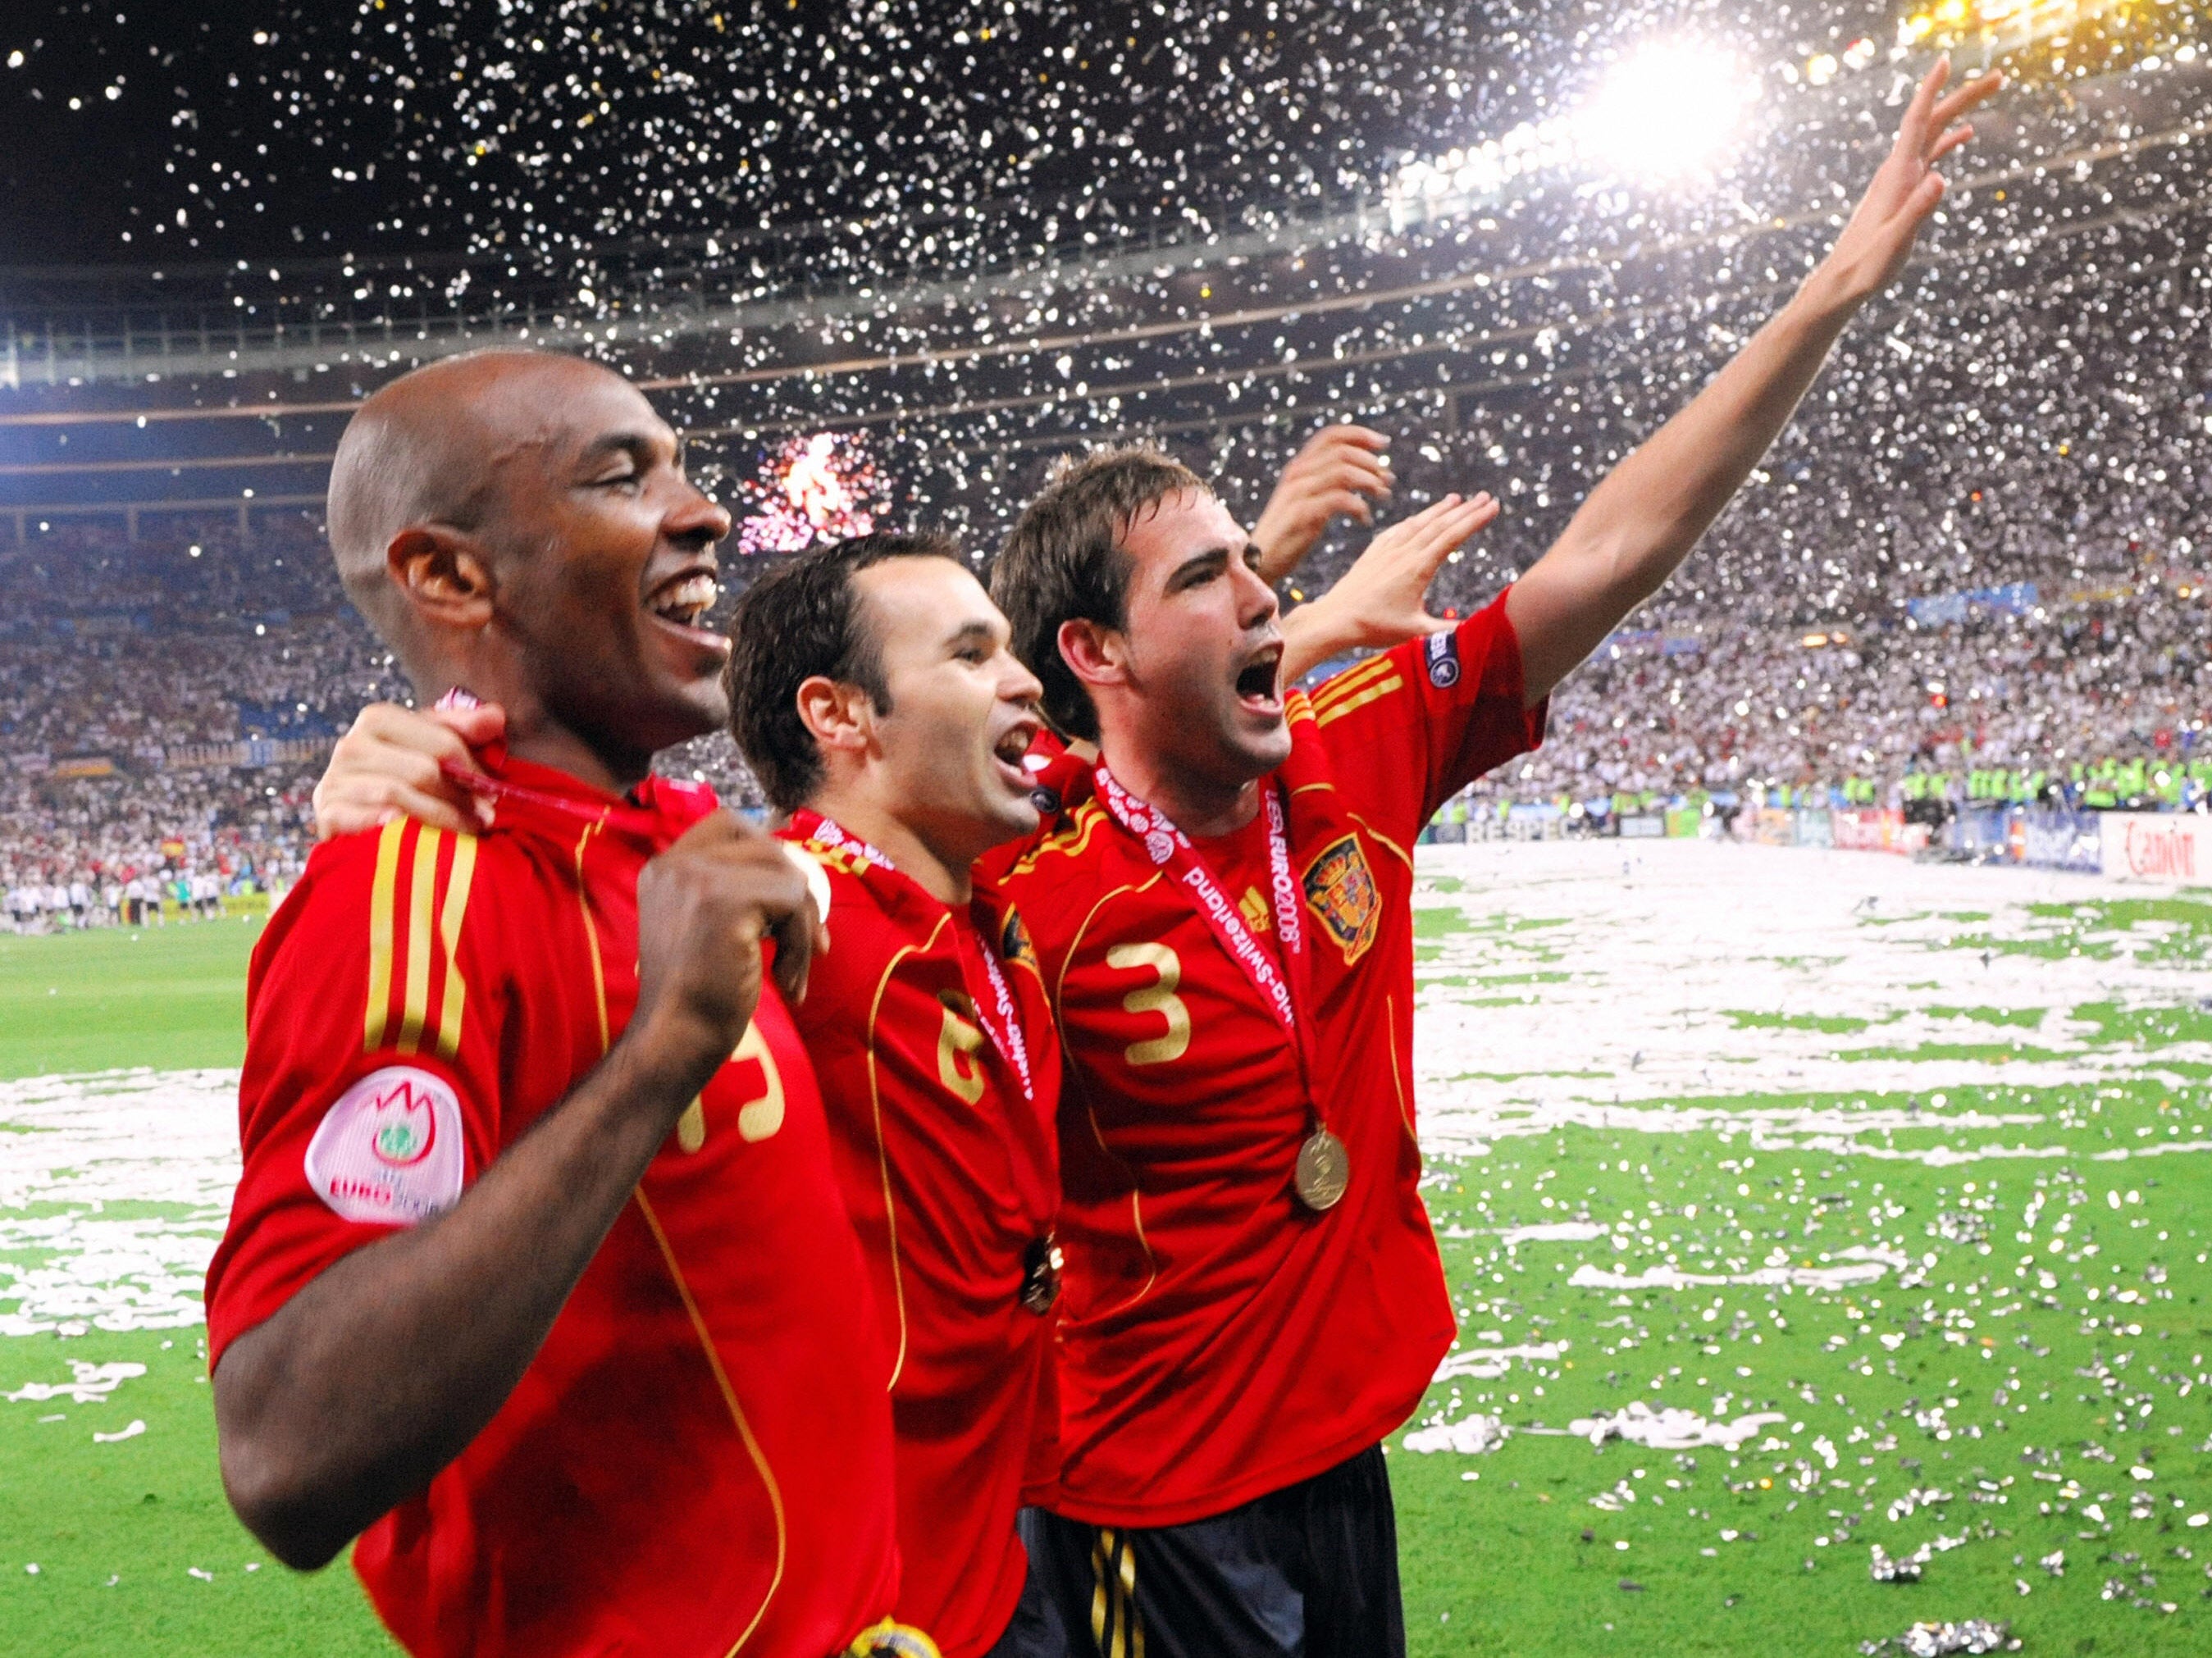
[0,522,778,933]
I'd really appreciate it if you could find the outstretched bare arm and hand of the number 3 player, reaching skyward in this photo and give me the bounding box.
[1507,57,2002,708]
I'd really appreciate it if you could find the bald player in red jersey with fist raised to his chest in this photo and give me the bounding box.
[208,352,898,1658]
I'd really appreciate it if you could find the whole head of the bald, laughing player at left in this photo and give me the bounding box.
[330,352,730,787]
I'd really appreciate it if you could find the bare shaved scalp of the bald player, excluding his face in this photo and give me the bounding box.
[330,352,644,645]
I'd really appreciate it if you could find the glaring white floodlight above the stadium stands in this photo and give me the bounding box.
[1575,42,1758,179]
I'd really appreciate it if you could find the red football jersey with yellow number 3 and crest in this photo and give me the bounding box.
[1004,599,1544,1525]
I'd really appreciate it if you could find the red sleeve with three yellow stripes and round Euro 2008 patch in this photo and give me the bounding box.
[208,822,504,1371]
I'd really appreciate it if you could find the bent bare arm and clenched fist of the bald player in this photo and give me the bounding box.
[215,813,814,1569]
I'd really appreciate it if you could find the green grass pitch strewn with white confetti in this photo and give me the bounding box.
[0,847,2212,1658]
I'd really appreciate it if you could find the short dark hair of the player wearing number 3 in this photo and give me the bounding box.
[991,444,1208,743]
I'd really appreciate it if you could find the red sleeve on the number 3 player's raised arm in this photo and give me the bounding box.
[1289,594,1551,847]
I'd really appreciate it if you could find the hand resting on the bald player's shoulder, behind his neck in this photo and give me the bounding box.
[314,703,507,840]
